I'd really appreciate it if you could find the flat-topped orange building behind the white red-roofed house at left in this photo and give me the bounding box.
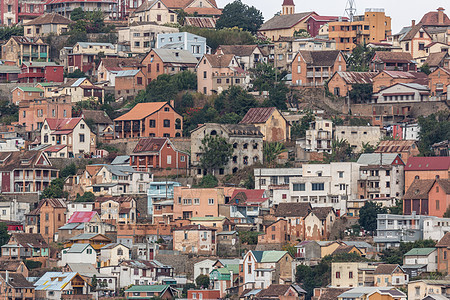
[19,95,72,131]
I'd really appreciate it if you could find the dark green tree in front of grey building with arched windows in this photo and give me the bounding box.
[200,135,233,175]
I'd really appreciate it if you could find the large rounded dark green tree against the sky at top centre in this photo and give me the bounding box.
[216,0,264,34]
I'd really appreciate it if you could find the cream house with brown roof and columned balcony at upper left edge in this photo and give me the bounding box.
[2,36,50,67]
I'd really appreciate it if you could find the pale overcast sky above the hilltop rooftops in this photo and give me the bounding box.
[216,0,450,33]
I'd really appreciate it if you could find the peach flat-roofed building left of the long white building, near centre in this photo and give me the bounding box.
[173,186,234,220]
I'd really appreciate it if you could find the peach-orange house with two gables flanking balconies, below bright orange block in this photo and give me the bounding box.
[292,50,347,86]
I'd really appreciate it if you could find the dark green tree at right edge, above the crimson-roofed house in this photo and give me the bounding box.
[418,110,450,156]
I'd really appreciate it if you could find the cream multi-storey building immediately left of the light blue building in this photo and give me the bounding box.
[117,21,178,54]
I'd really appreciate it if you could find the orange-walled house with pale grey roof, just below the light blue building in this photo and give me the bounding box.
[141,48,198,84]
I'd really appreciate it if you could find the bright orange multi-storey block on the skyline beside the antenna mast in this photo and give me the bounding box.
[328,8,391,52]
